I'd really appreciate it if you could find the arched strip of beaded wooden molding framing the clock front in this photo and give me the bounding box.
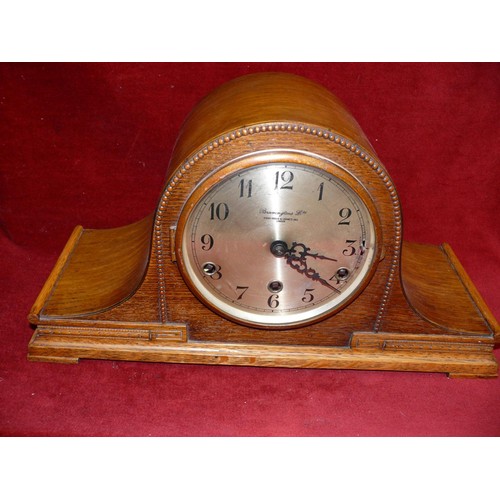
[153,123,402,332]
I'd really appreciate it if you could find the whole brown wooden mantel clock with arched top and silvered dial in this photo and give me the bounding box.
[28,69,500,377]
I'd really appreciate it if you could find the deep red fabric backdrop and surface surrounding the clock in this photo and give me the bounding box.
[0,63,500,436]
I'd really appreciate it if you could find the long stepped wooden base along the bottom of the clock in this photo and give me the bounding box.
[28,325,498,378]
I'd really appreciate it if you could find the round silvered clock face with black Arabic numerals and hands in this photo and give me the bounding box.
[177,161,377,327]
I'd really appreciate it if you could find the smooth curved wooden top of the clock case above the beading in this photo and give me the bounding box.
[165,73,375,173]
